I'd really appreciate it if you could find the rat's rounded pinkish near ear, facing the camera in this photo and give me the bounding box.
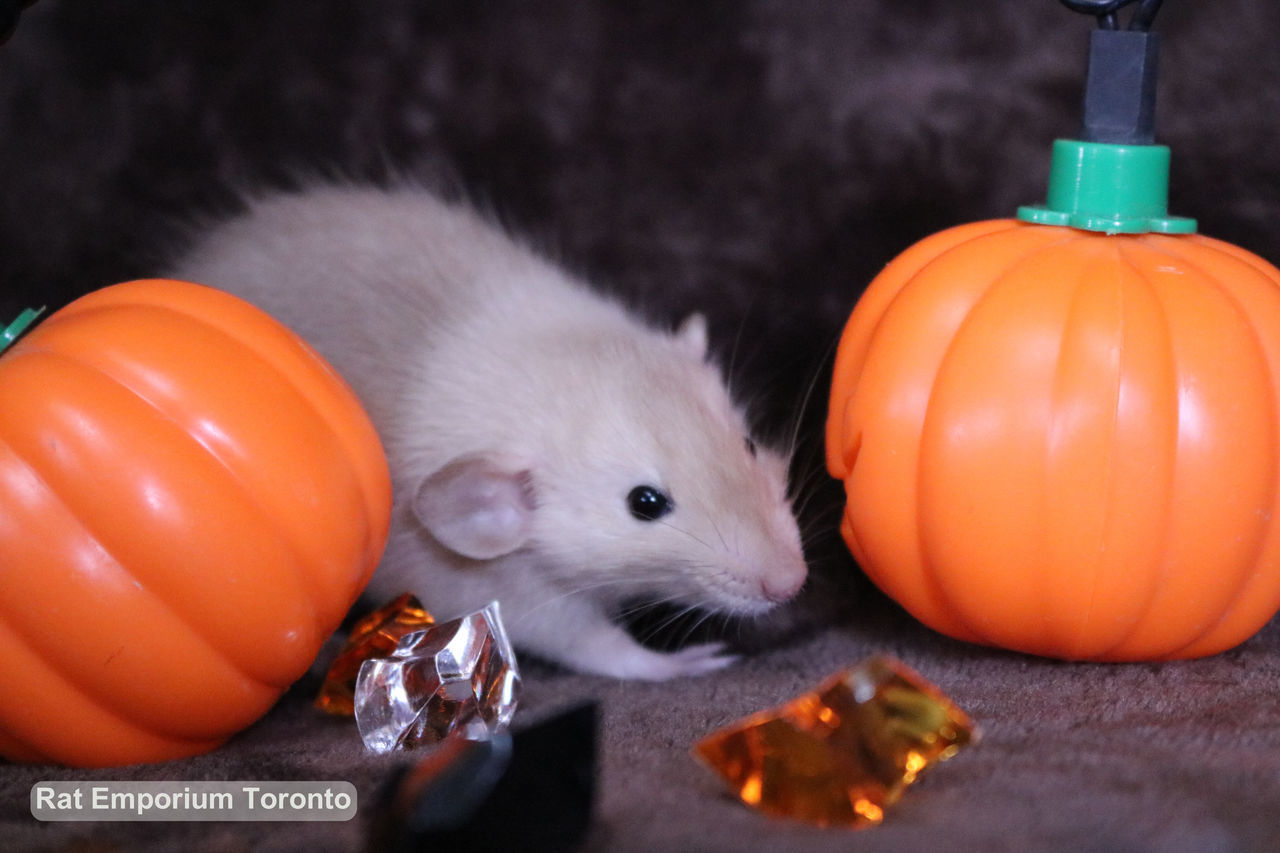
[413,453,535,560]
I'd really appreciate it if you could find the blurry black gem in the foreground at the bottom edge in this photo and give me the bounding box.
[369,704,596,853]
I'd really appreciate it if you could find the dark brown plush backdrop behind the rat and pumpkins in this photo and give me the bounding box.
[10,0,1280,617]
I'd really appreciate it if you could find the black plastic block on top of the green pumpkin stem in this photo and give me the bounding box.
[1080,29,1160,145]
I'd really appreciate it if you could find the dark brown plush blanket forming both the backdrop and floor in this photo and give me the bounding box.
[0,0,1280,853]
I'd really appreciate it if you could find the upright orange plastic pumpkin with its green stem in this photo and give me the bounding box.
[827,4,1280,661]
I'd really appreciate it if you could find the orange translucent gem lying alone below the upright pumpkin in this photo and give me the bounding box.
[694,657,978,826]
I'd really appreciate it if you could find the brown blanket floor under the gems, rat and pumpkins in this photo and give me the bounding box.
[0,596,1280,853]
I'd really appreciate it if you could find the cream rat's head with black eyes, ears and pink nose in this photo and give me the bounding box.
[415,308,805,615]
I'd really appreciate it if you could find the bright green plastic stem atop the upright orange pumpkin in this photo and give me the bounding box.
[1018,140,1196,234]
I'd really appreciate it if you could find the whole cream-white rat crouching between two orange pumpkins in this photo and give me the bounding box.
[166,187,805,680]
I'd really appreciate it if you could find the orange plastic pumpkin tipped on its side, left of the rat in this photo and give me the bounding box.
[0,280,390,766]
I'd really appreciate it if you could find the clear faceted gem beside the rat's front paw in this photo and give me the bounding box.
[355,602,520,752]
